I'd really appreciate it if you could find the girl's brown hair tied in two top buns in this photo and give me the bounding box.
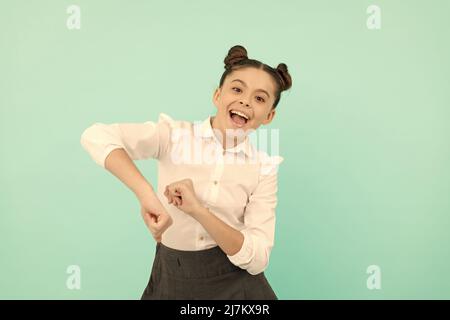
[219,45,292,109]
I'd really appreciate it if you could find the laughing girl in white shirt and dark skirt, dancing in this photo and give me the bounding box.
[81,46,292,300]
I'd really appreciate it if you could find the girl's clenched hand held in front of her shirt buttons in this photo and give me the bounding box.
[164,179,201,215]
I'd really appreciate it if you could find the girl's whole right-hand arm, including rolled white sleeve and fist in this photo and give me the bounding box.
[164,162,277,275]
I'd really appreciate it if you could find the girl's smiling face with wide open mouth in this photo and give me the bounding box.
[213,67,276,136]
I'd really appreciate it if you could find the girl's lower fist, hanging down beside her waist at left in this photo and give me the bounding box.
[139,193,173,242]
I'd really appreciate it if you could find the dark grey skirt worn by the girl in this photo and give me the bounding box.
[141,242,278,300]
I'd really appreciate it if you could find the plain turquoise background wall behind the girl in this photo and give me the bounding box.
[0,0,450,299]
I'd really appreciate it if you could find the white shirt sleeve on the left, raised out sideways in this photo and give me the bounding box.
[80,113,173,168]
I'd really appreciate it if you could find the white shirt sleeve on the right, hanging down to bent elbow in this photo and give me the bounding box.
[227,156,283,275]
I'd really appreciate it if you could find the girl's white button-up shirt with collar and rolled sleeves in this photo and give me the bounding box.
[80,113,283,275]
